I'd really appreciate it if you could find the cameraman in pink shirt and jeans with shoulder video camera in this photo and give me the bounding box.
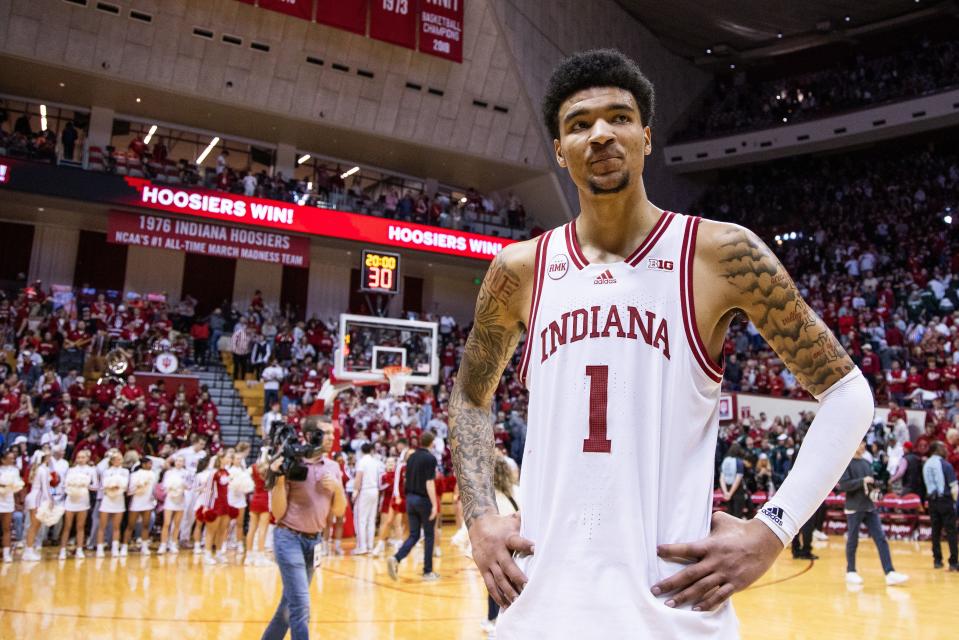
[263,416,346,640]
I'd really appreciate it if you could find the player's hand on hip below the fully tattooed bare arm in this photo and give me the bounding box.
[469,513,533,607]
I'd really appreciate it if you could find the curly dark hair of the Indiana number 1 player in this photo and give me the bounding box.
[543,49,655,139]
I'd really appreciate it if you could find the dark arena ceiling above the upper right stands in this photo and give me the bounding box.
[617,0,957,66]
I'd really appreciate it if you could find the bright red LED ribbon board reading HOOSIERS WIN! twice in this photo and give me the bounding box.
[118,176,514,261]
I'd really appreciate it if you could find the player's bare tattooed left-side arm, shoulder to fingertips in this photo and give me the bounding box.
[449,241,536,606]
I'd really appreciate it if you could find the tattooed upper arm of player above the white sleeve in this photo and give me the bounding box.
[719,227,854,394]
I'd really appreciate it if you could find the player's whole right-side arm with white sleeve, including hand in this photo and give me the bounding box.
[653,222,873,611]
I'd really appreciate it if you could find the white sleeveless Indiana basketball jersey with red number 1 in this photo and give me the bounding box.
[497,212,738,640]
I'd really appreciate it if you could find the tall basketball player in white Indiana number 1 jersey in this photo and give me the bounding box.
[449,50,873,640]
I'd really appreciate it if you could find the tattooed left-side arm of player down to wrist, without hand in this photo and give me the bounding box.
[449,252,522,526]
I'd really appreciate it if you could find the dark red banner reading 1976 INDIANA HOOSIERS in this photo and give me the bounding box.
[107,211,310,268]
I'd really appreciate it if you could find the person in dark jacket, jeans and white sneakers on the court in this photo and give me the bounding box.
[839,440,909,585]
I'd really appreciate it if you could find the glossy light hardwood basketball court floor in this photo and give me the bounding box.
[0,528,959,640]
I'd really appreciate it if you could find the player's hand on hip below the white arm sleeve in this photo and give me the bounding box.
[652,511,783,611]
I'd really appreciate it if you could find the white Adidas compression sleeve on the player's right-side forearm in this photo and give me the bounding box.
[756,367,875,546]
